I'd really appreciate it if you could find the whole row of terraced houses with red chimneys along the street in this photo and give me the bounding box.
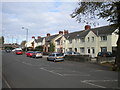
[27,25,118,57]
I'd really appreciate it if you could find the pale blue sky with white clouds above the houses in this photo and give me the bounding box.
[0,0,109,44]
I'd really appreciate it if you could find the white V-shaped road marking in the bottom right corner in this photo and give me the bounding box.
[81,80,118,88]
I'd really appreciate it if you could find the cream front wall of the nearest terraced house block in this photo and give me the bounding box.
[62,31,118,57]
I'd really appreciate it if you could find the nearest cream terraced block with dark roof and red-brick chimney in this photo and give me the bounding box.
[61,25,118,57]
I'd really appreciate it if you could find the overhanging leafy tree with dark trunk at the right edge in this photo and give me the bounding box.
[71,0,120,70]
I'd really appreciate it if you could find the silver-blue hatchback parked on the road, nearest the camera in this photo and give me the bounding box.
[47,53,64,62]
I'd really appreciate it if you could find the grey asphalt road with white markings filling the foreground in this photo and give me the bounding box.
[2,52,118,88]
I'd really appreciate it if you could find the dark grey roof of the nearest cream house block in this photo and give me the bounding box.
[64,24,117,40]
